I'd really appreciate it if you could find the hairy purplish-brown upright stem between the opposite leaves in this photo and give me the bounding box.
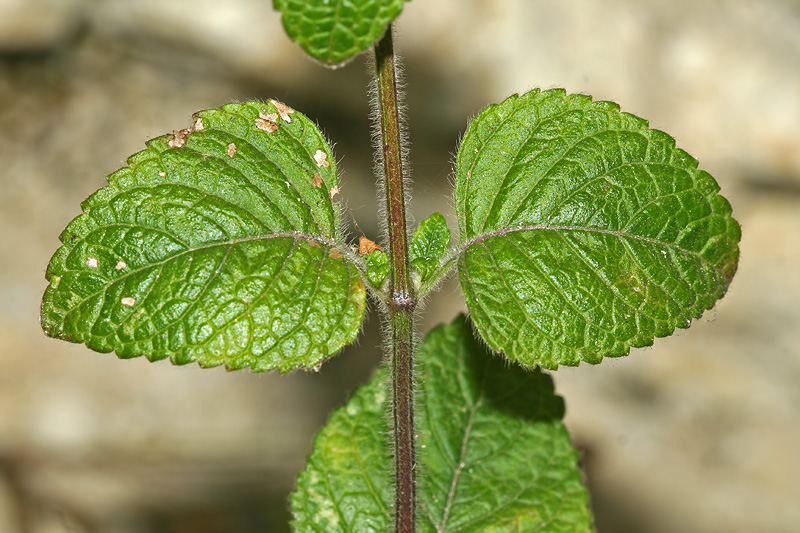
[375,25,416,533]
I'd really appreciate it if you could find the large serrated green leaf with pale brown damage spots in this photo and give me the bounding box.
[42,100,365,371]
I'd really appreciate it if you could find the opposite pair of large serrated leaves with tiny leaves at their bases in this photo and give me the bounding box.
[42,90,740,372]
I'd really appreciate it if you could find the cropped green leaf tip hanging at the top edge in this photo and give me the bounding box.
[272,0,408,67]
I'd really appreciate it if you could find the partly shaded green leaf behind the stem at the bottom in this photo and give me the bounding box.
[291,317,591,533]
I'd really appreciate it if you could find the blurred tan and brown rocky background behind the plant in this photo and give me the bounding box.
[0,0,800,533]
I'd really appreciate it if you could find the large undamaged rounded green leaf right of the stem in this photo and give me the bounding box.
[455,89,741,368]
